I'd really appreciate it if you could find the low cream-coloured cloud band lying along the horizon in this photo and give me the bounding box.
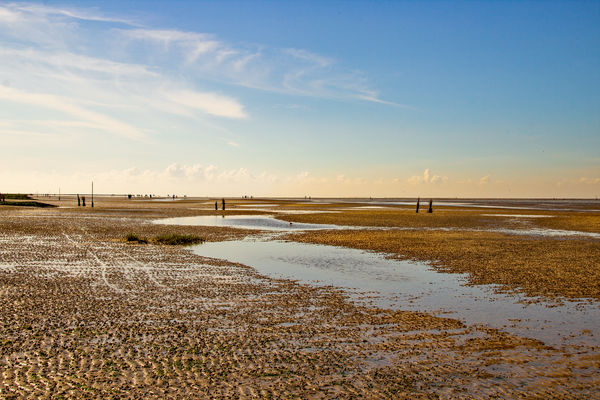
[0,163,600,198]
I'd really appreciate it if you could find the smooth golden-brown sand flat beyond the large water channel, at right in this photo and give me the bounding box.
[279,208,600,300]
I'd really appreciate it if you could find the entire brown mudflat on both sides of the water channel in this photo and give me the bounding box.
[0,197,600,399]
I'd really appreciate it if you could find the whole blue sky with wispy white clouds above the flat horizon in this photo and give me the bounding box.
[0,0,600,198]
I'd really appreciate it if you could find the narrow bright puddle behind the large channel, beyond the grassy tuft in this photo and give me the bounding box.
[154,215,352,231]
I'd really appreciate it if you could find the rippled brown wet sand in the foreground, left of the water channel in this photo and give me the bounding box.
[0,198,600,399]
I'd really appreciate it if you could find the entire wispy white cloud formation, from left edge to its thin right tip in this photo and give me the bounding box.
[0,3,404,150]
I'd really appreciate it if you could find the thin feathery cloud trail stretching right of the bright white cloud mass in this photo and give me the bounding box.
[116,25,394,103]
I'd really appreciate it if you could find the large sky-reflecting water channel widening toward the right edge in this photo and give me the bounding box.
[195,240,600,346]
